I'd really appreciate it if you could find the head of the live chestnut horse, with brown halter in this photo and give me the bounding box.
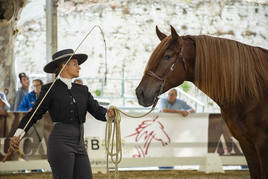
[136,26,195,107]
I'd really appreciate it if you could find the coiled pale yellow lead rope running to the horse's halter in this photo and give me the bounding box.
[105,103,156,179]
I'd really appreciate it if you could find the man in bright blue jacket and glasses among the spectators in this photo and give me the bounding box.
[18,79,43,111]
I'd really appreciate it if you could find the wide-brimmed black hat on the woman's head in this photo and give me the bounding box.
[44,49,87,73]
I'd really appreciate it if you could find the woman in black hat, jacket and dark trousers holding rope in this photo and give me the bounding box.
[10,49,114,179]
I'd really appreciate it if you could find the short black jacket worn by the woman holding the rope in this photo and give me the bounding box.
[18,79,107,132]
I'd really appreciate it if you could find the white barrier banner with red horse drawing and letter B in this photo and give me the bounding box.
[85,113,208,158]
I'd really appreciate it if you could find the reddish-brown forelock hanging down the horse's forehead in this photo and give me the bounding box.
[144,36,172,74]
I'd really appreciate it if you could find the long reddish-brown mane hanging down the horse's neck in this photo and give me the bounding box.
[193,35,268,104]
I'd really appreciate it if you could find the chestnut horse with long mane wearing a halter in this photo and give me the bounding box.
[136,26,268,179]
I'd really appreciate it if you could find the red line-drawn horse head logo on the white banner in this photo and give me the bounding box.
[126,116,170,158]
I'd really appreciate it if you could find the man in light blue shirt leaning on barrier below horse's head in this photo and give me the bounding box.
[159,88,195,117]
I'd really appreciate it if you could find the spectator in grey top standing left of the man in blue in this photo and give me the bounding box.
[14,73,30,111]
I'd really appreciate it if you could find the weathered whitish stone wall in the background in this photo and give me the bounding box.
[15,0,268,107]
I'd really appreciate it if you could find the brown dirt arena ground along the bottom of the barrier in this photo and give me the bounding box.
[0,170,250,179]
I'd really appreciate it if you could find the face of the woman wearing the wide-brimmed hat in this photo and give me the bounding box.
[62,59,81,78]
